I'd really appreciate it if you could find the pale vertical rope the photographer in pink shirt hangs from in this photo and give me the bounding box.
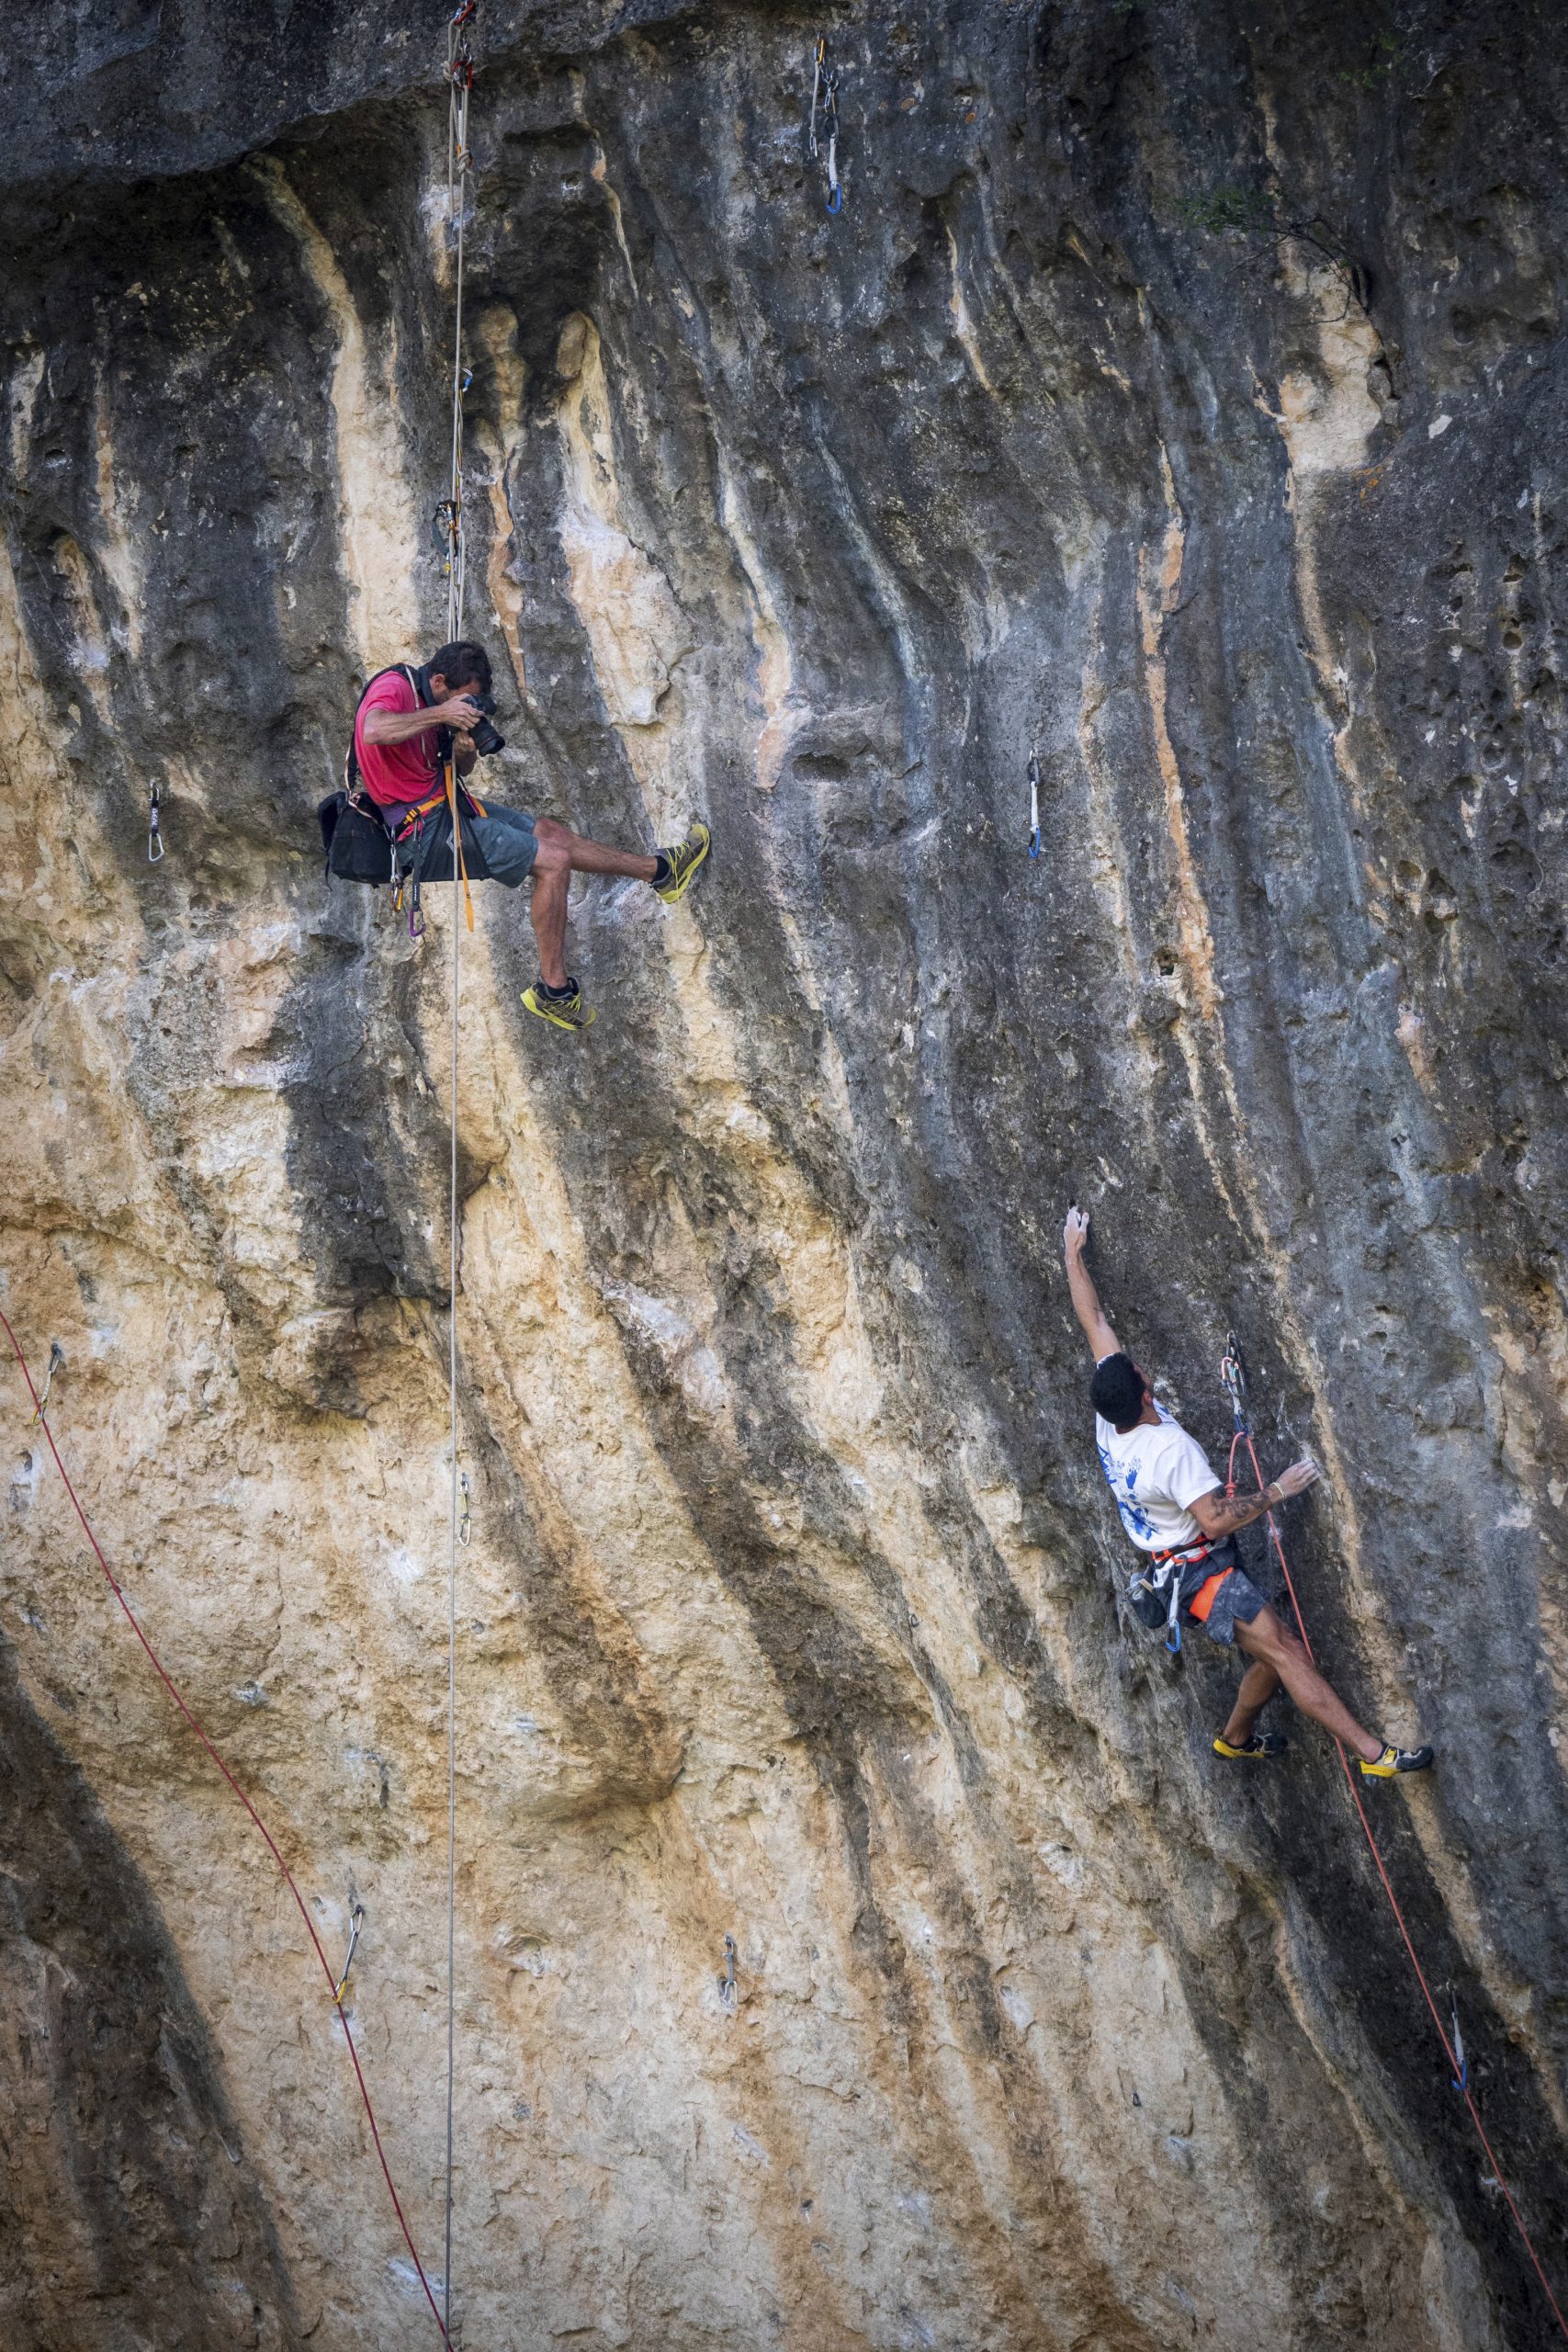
[442,0,478,2338]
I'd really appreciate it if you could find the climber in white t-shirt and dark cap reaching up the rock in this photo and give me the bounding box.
[1063,1209,1432,1781]
